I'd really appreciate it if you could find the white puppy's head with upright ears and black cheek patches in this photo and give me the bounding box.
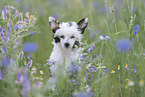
[49,17,88,49]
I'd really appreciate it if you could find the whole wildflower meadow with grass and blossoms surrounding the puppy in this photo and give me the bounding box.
[0,0,145,97]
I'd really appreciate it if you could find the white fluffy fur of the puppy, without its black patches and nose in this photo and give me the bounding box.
[48,17,88,88]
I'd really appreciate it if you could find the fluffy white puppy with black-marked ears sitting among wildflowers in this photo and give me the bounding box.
[49,16,88,88]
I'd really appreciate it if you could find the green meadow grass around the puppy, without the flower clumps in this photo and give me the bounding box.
[0,0,145,97]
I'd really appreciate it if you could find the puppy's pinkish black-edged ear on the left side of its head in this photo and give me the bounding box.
[49,16,59,33]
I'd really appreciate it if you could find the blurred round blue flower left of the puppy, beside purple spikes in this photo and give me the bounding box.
[23,42,38,53]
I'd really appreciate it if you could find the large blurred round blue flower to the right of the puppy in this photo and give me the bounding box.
[116,38,132,51]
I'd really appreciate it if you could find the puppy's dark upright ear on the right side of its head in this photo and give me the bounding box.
[78,18,88,34]
